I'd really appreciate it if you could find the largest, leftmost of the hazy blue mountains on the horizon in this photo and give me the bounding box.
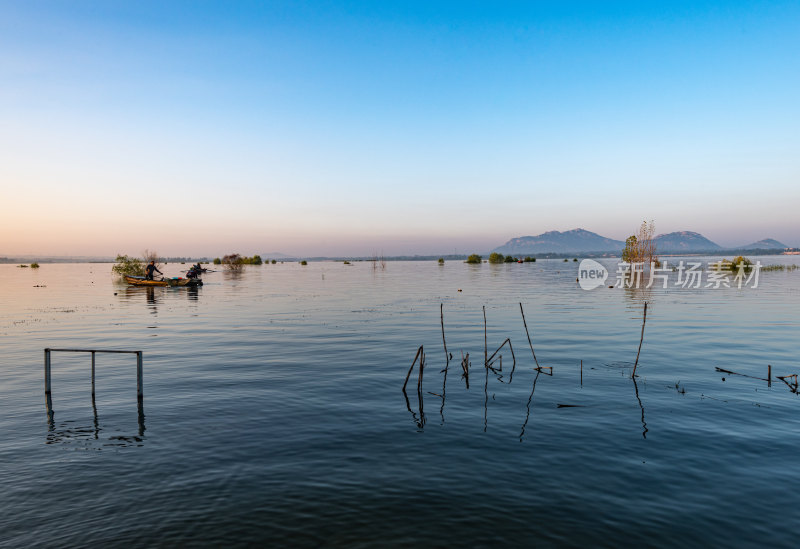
[492,229,625,255]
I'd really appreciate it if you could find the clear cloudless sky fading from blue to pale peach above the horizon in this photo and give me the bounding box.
[0,0,800,256]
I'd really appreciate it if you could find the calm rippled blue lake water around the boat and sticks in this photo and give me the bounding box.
[0,257,800,547]
